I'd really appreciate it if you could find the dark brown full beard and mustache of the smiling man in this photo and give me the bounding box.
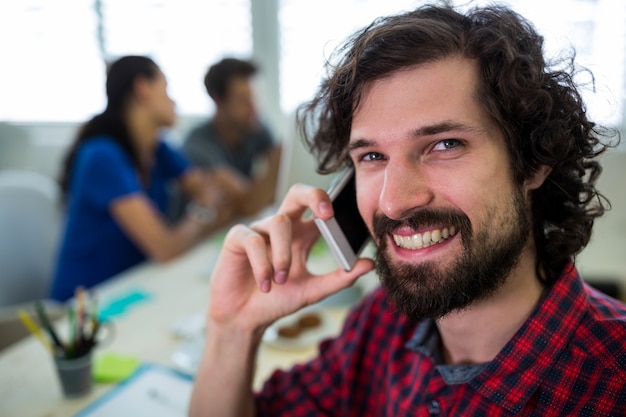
[374,188,532,322]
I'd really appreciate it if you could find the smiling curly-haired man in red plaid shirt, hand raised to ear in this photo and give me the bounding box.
[190,6,626,417]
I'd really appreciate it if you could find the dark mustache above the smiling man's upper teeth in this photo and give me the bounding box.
[373,208,472,241]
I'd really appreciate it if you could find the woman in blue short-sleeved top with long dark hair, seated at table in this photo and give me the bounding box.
[51,56,228,301]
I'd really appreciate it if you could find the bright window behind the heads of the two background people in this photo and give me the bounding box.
[0,0,252,122]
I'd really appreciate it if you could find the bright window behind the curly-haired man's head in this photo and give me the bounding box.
[279,0,626,130]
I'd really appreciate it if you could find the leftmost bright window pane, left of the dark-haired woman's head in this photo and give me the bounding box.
[0,0,104,121]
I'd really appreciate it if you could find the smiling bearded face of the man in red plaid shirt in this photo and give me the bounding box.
[349,57,531,320]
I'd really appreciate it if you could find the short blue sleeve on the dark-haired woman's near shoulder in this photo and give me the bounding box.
[72,140,141,207]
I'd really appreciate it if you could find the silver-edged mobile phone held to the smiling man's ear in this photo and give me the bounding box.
[314,168,370,271]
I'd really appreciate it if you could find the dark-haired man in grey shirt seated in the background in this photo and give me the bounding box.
[179,58,280,221]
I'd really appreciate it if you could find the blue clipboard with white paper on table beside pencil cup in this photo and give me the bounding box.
[75,364,193,417]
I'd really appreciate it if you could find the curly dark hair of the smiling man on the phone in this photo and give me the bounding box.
[298,5,619,285]
